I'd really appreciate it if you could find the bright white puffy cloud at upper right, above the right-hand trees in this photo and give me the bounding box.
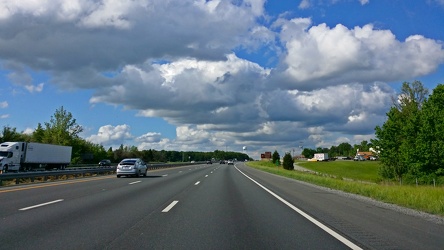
[278,19,444,89]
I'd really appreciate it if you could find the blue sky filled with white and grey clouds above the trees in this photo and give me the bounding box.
[0,0,444,159]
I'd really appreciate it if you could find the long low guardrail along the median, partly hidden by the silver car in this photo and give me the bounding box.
[0,162,202,186]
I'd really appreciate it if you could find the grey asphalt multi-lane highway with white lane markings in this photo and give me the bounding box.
[0,163,444,249]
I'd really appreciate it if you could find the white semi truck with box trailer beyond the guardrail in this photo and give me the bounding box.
[0,142,72,172]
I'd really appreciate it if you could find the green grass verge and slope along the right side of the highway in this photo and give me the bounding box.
[247,161,444,216]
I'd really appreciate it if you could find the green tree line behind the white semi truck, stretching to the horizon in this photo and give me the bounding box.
[0,106,251,164]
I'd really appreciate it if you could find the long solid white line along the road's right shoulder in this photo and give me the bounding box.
[235,166,362,250]
